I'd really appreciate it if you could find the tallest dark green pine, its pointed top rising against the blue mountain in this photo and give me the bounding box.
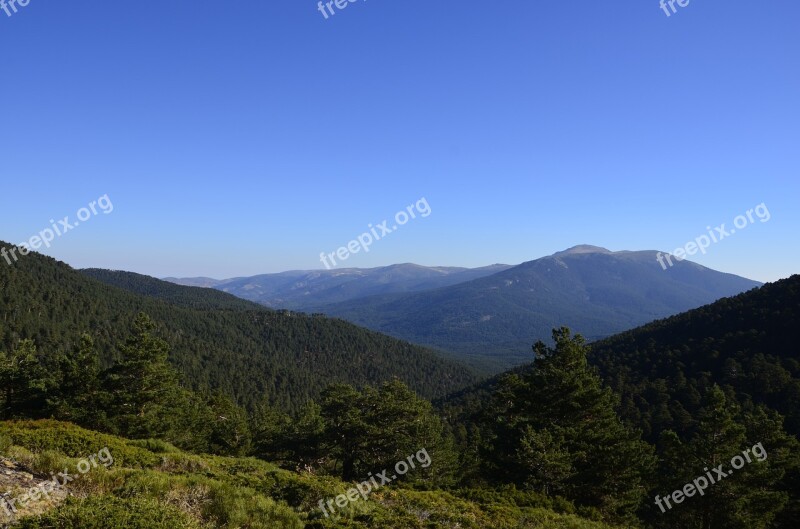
[490,328,655,521]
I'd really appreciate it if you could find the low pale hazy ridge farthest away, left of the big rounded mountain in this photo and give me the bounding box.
[164,263,511,311]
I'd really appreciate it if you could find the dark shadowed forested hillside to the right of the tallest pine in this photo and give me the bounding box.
[591,275,800,439]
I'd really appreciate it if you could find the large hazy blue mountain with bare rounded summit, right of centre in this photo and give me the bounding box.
[318,245,760,370]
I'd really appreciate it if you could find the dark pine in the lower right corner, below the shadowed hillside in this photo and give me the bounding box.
[654,385,796,529]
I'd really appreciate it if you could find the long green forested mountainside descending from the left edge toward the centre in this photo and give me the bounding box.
[0,242,476,410]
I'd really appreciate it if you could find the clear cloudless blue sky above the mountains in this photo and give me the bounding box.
[0,0,800,281]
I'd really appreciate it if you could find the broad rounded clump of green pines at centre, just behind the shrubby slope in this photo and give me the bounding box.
[254,380,455,485]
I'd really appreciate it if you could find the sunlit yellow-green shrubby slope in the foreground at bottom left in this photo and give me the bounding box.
[0,421,624,529]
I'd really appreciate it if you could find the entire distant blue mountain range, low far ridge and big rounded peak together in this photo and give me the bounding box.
[164,245,761,371]
